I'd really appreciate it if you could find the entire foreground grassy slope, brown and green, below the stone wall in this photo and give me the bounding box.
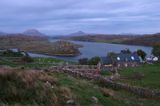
[0,65,160,106]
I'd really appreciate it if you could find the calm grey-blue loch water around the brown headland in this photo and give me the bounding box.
[30,40,152,61]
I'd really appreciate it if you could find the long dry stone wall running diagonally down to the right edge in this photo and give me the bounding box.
[50,66,160,98]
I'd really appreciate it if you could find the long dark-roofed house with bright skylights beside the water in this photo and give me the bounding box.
[100,53,142,68]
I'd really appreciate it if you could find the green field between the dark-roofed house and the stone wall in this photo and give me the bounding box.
[120,63,160,89]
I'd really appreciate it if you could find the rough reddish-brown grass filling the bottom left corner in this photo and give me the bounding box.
[0,68,71,106]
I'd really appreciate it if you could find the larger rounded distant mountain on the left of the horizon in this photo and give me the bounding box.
[23,29,45,36]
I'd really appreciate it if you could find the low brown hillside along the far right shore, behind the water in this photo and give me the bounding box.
[59,33,160,46]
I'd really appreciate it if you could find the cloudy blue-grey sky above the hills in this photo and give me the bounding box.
[0,0,160,35]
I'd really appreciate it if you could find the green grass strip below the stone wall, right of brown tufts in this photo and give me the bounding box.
[54,74,160,106]
